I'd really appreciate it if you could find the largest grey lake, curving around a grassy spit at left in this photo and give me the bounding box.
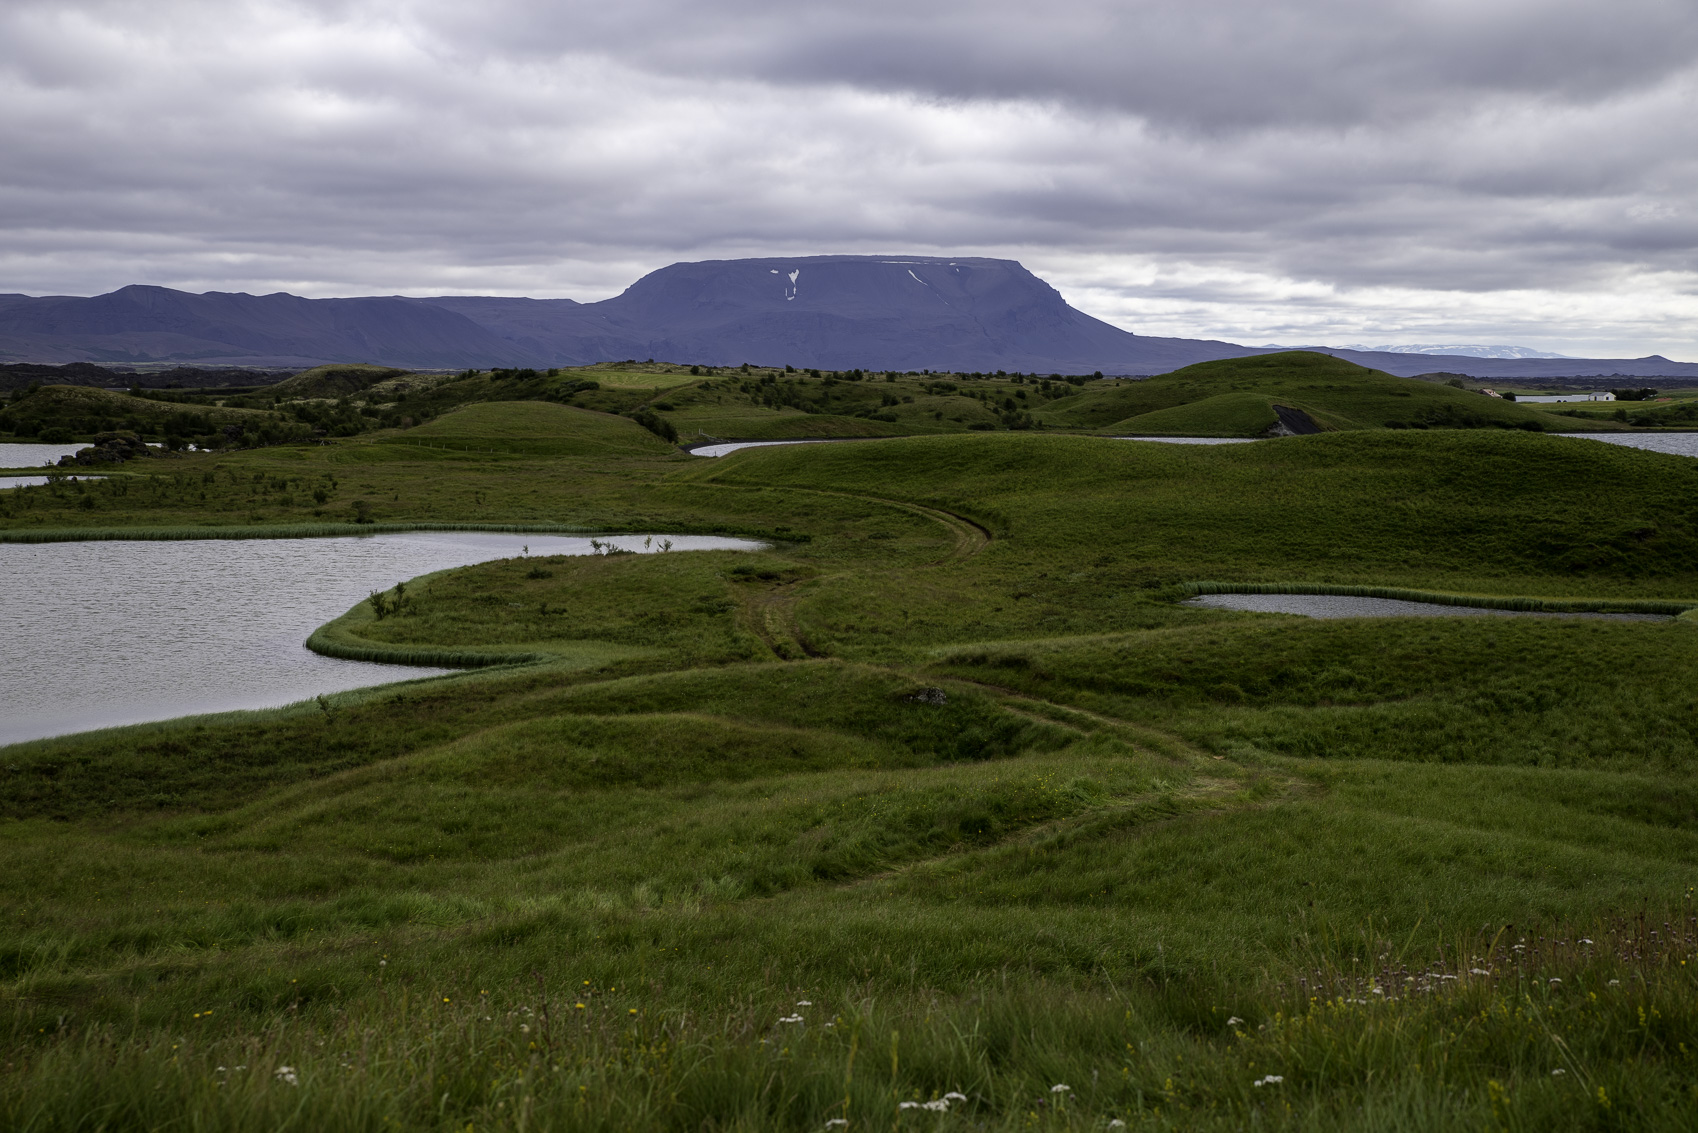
[0,532,761,744]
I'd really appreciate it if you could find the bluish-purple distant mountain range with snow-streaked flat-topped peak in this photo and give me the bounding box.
[0,255,1698,379]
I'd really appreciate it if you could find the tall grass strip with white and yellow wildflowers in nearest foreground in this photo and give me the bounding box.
[0,900,1698,1133]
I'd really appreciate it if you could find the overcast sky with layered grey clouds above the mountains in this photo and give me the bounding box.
[0,0,1698,360]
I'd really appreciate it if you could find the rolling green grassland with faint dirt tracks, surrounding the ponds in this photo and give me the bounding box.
[0,377,1698,1131]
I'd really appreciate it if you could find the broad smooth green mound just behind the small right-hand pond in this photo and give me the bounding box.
[688,431,1698,597]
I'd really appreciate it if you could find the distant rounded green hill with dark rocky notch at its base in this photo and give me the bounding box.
[1039,350,1576,437]
